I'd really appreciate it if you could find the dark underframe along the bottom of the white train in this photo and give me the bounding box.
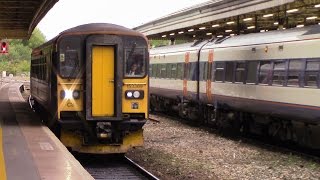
[150,94,320,150]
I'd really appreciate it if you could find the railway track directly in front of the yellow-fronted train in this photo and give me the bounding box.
[75,154,158,180]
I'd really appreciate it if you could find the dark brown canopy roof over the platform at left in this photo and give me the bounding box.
[0,0,59,39]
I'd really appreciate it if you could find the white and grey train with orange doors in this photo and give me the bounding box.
[149,25,320,149]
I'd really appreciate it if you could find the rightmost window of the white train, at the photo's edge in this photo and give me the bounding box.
[304,59,320,88]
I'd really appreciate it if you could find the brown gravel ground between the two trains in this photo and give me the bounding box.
[127,115,320,180]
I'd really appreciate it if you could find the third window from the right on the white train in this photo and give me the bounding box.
[272,61,286,86]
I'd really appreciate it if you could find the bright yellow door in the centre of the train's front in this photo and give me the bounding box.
[92,46,115,117]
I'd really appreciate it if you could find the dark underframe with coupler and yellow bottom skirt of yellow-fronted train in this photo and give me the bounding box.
[32,100,146,154]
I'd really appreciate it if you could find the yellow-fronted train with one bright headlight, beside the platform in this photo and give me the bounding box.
[30,23,149,153]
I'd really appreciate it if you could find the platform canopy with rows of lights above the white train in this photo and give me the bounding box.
[134,0,320,40]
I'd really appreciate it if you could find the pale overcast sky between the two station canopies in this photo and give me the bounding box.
[37,0,208,40]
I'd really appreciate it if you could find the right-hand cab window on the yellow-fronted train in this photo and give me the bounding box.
[125,48,146,77]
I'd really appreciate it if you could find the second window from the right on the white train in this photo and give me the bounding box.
[287,59,304,87]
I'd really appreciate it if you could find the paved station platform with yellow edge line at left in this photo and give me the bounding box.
[0,82,93,180]
